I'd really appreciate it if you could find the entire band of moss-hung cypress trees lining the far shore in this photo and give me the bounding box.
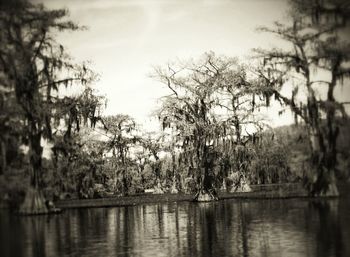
[0,0,350,213]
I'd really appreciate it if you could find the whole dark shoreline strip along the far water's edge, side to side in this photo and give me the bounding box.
[0,182,350,212]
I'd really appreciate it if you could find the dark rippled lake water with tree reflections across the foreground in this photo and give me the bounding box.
[0,192,350,257]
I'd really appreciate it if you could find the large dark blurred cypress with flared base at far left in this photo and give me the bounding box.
[0,0,103,214]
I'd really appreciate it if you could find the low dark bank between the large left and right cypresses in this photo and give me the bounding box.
[55,183,308,209]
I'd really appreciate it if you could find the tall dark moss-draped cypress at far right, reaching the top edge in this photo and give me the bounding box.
[256,0,350,196]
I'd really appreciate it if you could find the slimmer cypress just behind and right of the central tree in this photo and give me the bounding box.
[217,63,266,191]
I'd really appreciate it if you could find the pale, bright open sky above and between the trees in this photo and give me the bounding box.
[34,0,350,129]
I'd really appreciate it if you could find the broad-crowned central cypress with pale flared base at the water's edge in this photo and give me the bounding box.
[156,53,260,201]
